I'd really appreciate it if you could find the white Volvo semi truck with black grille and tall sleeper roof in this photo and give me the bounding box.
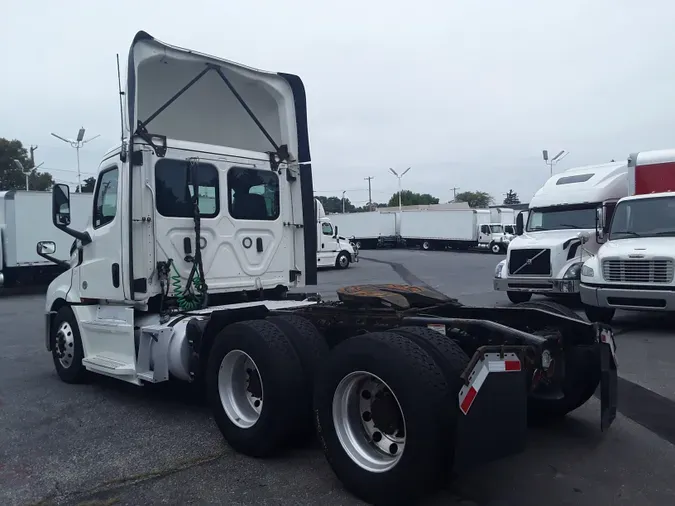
[493,162,628,303]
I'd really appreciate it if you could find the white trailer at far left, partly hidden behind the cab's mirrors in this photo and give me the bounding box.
[0,190,92,287]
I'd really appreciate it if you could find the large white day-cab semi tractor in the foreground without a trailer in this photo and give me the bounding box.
[37,32,617,505]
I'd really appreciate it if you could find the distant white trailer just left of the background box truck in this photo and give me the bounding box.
[330,211,398,249]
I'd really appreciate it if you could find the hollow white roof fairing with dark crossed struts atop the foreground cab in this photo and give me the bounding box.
[126,31,310,162]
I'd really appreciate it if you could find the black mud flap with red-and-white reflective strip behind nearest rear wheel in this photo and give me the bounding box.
[453,353,527,473]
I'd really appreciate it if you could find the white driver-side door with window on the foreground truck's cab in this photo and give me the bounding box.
[76,160,125,301]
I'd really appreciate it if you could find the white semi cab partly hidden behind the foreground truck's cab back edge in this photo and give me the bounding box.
[314,199,359,269]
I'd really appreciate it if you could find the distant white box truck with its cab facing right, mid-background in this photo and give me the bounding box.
[401,209,508,253]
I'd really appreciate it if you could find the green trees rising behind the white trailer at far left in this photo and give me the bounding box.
[0,137,96,193]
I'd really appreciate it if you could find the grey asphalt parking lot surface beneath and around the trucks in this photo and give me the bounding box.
[0,250,675,506]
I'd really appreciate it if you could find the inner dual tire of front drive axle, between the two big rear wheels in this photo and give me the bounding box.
[267,315,330,439]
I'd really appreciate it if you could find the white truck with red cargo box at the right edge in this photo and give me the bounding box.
[581,149,675,323]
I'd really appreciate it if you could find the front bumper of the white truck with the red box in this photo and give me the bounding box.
[580,285,675,311]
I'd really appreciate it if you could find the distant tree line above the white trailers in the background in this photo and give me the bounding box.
[316,190,520,214]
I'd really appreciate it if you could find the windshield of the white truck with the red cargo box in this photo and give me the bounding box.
[609,196,675,240]
